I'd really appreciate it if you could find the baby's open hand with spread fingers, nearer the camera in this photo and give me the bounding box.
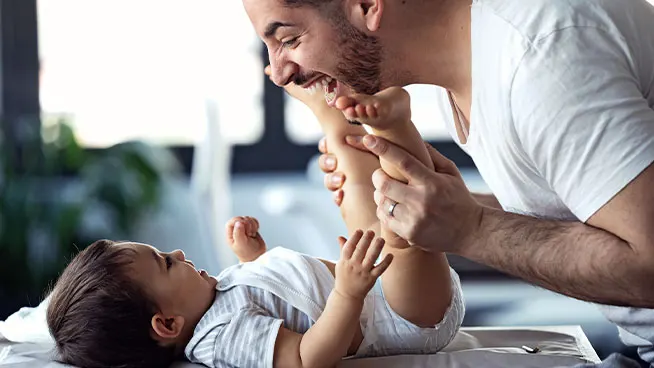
[335,230,393,299]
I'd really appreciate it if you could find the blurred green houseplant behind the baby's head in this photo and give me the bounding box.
[0,116,180,319]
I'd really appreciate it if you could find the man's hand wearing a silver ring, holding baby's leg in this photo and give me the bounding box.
[363,136,483,253]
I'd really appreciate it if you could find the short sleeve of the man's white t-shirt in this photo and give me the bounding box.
[511,27,654,222]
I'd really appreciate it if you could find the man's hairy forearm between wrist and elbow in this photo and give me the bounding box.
[461,208,654,308]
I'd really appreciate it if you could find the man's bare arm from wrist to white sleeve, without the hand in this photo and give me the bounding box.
[461,162,654,308]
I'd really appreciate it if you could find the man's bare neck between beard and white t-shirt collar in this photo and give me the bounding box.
[385,0,472,95]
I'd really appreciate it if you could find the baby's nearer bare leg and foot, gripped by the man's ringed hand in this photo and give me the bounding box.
[337,87,452,327]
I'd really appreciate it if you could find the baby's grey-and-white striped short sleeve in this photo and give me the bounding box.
[194,305,283,368]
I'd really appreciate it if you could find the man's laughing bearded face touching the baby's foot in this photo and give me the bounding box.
[243,0,382,104]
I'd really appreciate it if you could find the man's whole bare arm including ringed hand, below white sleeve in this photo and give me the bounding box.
[368,137,654,308]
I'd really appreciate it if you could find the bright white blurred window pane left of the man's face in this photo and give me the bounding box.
[38,0,263,147]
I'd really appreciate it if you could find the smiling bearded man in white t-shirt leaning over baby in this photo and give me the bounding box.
[243,0,654,362]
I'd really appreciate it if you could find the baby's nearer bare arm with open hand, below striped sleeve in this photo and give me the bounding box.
[274,230,392,367]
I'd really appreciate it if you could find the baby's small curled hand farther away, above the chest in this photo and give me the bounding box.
[225,216,266,262]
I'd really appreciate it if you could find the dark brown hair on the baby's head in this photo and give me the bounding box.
[47,240,175,368]
